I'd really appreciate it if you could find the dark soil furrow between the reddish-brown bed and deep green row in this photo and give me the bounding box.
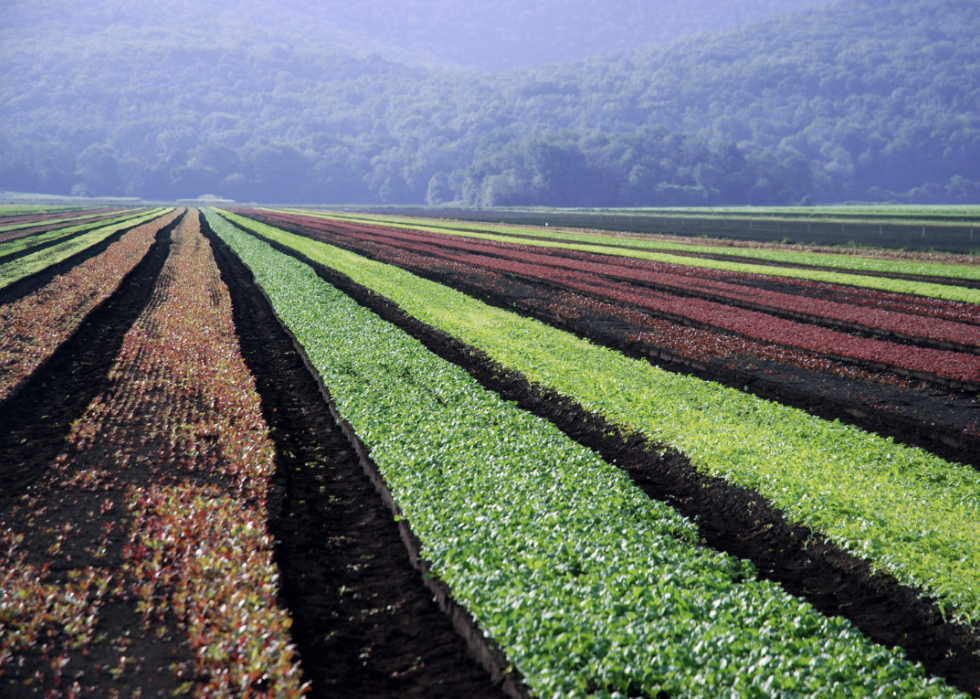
[202,213,504,699]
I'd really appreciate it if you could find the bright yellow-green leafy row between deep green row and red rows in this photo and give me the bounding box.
[225,214,980,620]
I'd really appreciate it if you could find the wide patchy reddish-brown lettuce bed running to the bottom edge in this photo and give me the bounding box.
[0,214,307,698]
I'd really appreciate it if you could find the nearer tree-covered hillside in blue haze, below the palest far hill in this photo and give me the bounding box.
[0,0,980,206]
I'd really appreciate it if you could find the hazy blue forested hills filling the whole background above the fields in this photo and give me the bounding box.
[0,0,980,206]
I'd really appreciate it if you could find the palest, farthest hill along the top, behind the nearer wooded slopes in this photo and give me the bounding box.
[0,0,830,72]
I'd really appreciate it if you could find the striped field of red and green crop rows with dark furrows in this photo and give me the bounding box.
[0,207,980,699]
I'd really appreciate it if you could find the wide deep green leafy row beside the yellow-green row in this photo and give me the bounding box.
[205,210,955,699]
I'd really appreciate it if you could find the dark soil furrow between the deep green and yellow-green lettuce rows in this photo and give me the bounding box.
[234,221,980,696]
